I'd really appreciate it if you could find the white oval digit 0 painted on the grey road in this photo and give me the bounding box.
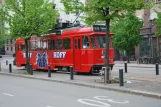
[77,99,111,107]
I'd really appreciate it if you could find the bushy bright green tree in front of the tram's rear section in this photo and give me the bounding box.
[1,0,58,70]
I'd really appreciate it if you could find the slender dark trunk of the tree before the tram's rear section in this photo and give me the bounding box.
[25,39,30,72]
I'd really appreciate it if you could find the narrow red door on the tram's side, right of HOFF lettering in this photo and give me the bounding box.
[74,37,81,71]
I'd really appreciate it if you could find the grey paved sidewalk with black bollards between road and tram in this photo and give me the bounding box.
[0,63,161,99]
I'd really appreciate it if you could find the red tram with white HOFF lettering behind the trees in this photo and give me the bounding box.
[15,25,114,73]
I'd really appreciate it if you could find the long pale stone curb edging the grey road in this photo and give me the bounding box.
[0,72,161,99]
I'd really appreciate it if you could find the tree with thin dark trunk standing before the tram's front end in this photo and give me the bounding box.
[61,0,150,82]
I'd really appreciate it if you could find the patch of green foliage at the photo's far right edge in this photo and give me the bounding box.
[154,4,161,36]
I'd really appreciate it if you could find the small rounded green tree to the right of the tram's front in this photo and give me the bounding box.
[111,13,143,63]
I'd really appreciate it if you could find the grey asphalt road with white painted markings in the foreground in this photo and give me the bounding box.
[0,75,161,107]
